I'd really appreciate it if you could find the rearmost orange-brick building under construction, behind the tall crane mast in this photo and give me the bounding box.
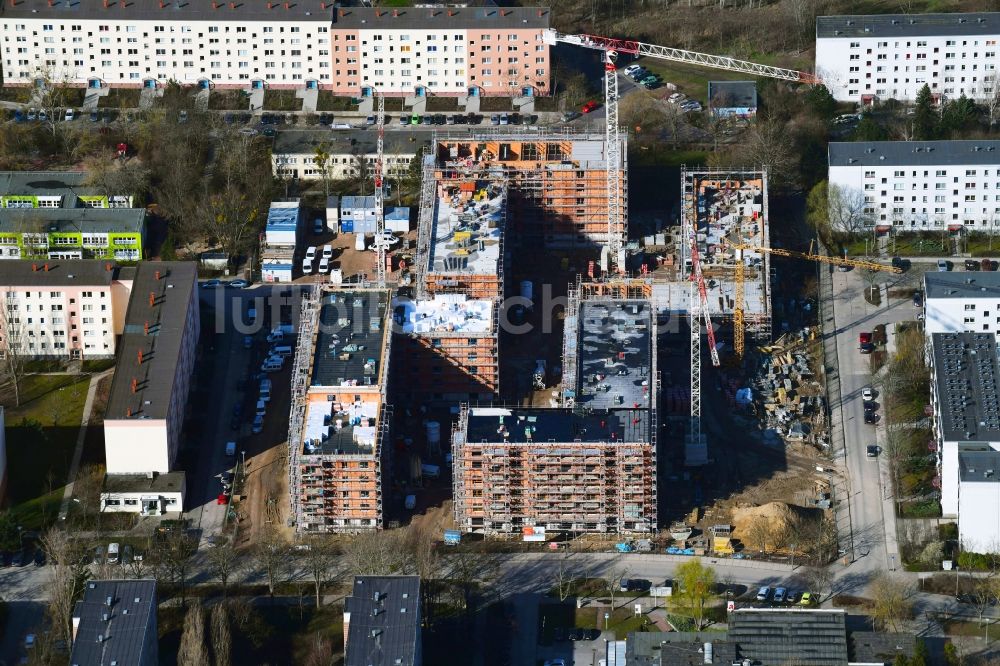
[434,128,628,250]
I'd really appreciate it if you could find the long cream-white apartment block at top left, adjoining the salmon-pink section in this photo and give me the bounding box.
[0,0,333,88]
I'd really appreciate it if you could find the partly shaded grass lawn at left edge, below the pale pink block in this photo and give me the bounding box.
[3,375,90,529]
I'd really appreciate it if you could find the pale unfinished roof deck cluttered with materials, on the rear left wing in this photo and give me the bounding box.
[427,180,507,275]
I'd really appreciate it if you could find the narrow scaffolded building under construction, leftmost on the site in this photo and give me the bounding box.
[288,286,392,532]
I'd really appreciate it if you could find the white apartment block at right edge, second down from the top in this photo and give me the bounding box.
[828,141,1000,232]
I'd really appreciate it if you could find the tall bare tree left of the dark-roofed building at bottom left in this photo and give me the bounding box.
[42,527,88,645]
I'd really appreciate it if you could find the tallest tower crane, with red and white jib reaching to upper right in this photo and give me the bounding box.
[542,29,821,272]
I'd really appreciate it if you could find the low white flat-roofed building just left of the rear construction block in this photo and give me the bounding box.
[271,130,433,180]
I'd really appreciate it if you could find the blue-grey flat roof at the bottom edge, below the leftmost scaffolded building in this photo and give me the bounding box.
[344,576,420,666]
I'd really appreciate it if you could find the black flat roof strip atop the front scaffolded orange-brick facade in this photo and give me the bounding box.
[466,407,649,444]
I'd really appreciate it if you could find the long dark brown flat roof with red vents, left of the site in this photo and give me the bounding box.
[104,261,198,421]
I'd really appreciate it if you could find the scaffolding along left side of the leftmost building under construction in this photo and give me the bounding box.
[288,285,320,525]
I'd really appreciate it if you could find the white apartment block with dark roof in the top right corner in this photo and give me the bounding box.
[816,13,1000,104]
